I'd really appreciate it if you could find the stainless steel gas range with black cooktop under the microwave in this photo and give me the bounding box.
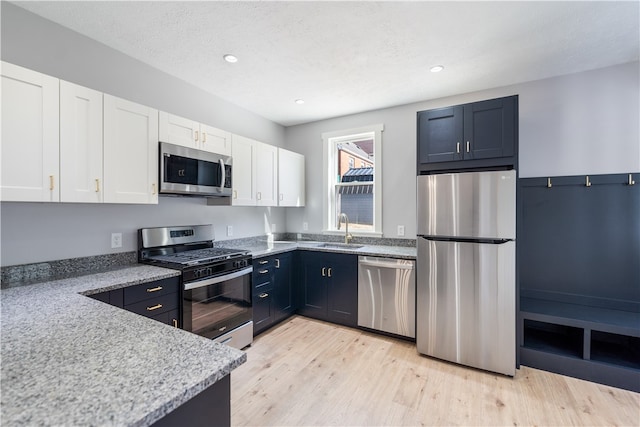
[138,224,253,348]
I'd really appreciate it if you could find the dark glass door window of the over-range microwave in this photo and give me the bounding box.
[164,155,224,187]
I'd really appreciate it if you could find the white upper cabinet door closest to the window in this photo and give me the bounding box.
[278,148,305,206]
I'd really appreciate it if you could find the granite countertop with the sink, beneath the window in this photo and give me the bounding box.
[239,241,416,259]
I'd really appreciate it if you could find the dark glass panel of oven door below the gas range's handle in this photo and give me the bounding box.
[183,274,252,338]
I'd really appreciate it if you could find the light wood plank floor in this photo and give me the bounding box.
[231,316,640,426]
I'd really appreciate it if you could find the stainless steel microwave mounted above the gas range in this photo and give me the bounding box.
[160,142,232,197]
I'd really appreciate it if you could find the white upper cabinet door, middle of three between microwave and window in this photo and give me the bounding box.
[254,142,278,206]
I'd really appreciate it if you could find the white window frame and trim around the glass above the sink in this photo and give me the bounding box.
[322,124,384,237]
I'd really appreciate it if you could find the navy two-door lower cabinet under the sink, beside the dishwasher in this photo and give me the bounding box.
[298,251,358,326]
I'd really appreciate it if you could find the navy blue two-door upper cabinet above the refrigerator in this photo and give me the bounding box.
[417,95,518,174]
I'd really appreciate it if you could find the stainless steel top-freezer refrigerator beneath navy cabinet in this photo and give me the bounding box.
[416,170,516,376]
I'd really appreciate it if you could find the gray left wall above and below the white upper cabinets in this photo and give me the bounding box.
[0,2,286,266]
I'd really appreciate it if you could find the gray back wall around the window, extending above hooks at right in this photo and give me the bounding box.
[286,62,640,238]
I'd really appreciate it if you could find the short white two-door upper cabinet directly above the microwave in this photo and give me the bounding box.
[159,111,231,155]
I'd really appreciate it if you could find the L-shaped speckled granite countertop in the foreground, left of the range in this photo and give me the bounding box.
[0,265,246,426]
